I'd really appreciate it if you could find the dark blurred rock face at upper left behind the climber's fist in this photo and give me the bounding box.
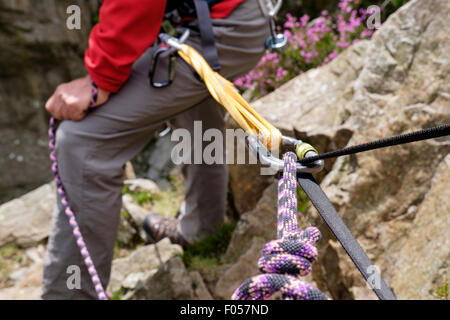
[0,0,97,203]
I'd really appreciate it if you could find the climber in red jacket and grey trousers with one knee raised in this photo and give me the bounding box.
[42,0,269,299]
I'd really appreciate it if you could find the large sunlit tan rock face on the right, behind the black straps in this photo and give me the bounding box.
[225,0,450,299]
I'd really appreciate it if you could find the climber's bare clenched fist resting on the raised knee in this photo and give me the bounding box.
[45,75,109,121]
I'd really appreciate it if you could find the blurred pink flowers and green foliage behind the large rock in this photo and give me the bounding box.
[235,0,408,100]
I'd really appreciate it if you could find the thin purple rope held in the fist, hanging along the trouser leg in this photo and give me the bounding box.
[48,83,108,300]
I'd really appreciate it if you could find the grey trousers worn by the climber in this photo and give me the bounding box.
[42,0,269,299]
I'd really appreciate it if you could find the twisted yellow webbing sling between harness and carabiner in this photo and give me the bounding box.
[178,44,281,150]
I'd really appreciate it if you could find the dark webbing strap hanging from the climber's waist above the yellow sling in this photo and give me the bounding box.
[194,0,220,71]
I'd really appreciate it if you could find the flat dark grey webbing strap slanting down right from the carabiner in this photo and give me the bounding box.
[297,173,396,300]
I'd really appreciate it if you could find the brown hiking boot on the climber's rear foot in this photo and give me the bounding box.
[144,213,188,247]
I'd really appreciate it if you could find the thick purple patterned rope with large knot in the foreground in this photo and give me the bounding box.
[231,152,328,300]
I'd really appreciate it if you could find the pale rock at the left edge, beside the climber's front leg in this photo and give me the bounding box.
[0,183,56,247]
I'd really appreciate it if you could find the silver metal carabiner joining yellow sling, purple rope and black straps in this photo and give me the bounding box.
[247,135,324,173]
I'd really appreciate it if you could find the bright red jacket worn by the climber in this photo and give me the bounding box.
[84,0,244,92]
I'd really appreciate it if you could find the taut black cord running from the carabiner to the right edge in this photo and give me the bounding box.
[300,124,450,164]
